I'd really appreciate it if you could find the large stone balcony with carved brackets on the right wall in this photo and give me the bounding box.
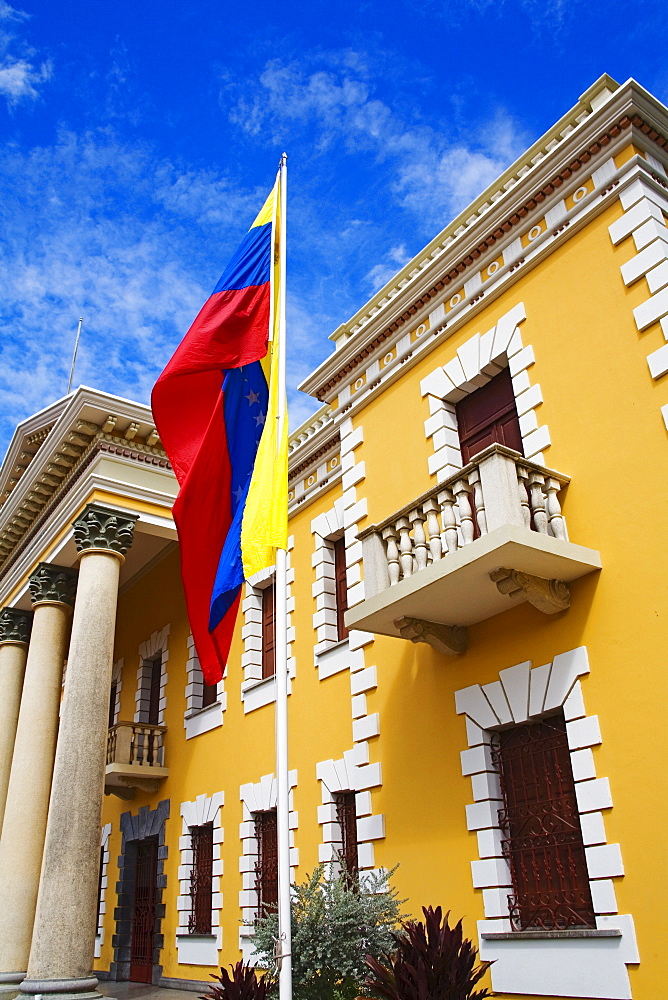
[346,444,601,654]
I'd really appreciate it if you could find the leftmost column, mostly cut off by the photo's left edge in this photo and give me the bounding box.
[0,608,32,830]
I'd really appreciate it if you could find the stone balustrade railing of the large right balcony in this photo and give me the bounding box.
[360,444,569,594]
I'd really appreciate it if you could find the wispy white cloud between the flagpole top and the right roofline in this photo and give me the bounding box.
[222,52,526,229]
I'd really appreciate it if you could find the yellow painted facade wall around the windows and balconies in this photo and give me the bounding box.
[99,178,668,1000]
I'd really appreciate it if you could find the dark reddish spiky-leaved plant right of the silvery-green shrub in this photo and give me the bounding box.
[364,906,491,1000]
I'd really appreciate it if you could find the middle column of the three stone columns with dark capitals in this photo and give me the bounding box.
[0,563,77,992]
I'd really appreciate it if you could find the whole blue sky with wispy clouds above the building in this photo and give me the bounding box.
[0,0,668,454]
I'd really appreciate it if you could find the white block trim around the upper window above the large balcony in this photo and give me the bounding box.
[420,302,550,483]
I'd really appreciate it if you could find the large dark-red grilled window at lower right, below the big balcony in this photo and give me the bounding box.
[492,712,596,930]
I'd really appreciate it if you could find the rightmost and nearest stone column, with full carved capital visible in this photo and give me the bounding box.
[21,504,137,1000]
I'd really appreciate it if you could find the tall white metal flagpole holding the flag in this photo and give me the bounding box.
[275,153,292,1000]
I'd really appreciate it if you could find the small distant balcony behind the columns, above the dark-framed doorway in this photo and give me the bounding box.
[104,722,169,799]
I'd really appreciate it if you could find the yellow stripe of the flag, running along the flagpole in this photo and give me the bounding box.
[241,180,288,580]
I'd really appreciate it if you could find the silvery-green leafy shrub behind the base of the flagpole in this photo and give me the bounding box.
[253,865,402,1000]
